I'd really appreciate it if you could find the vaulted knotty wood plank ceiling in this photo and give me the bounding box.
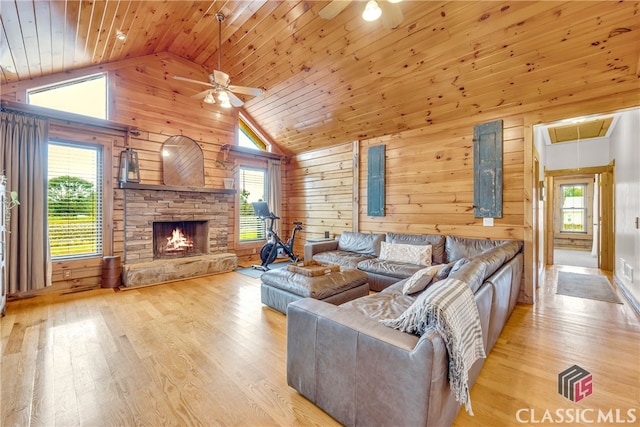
[0,0,640,153]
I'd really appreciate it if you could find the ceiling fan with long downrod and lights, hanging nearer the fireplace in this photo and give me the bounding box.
[173,12,262,108]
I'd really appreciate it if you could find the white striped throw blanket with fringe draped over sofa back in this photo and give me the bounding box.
[381,279,486,415]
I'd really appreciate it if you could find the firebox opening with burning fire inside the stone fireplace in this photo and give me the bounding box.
[153,221,209,259]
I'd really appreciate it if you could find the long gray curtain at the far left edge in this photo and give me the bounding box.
[0,111,51,294]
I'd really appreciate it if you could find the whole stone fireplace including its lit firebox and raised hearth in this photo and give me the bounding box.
[123,183,238,287]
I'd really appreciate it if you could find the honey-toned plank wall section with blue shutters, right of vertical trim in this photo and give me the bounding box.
[359,118,524,239]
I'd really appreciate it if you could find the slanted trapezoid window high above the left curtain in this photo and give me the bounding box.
[27,74,107,119]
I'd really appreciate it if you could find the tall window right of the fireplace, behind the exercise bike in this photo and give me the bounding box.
[239,167,267,242]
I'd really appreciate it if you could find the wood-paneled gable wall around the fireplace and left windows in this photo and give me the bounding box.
[2,53,245,290]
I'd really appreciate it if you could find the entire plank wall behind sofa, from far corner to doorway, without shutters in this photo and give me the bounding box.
[285,117,524,245]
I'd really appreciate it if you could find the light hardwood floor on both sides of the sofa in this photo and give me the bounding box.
[0,267,640,426]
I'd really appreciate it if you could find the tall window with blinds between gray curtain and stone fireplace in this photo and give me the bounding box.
[47,142,102,260]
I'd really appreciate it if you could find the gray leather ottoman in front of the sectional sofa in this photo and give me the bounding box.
[260,268,369,314]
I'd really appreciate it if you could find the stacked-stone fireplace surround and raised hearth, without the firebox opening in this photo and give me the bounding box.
[123,184,238,287]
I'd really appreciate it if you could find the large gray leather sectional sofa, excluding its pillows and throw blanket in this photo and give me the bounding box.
[287,234,523,426]
